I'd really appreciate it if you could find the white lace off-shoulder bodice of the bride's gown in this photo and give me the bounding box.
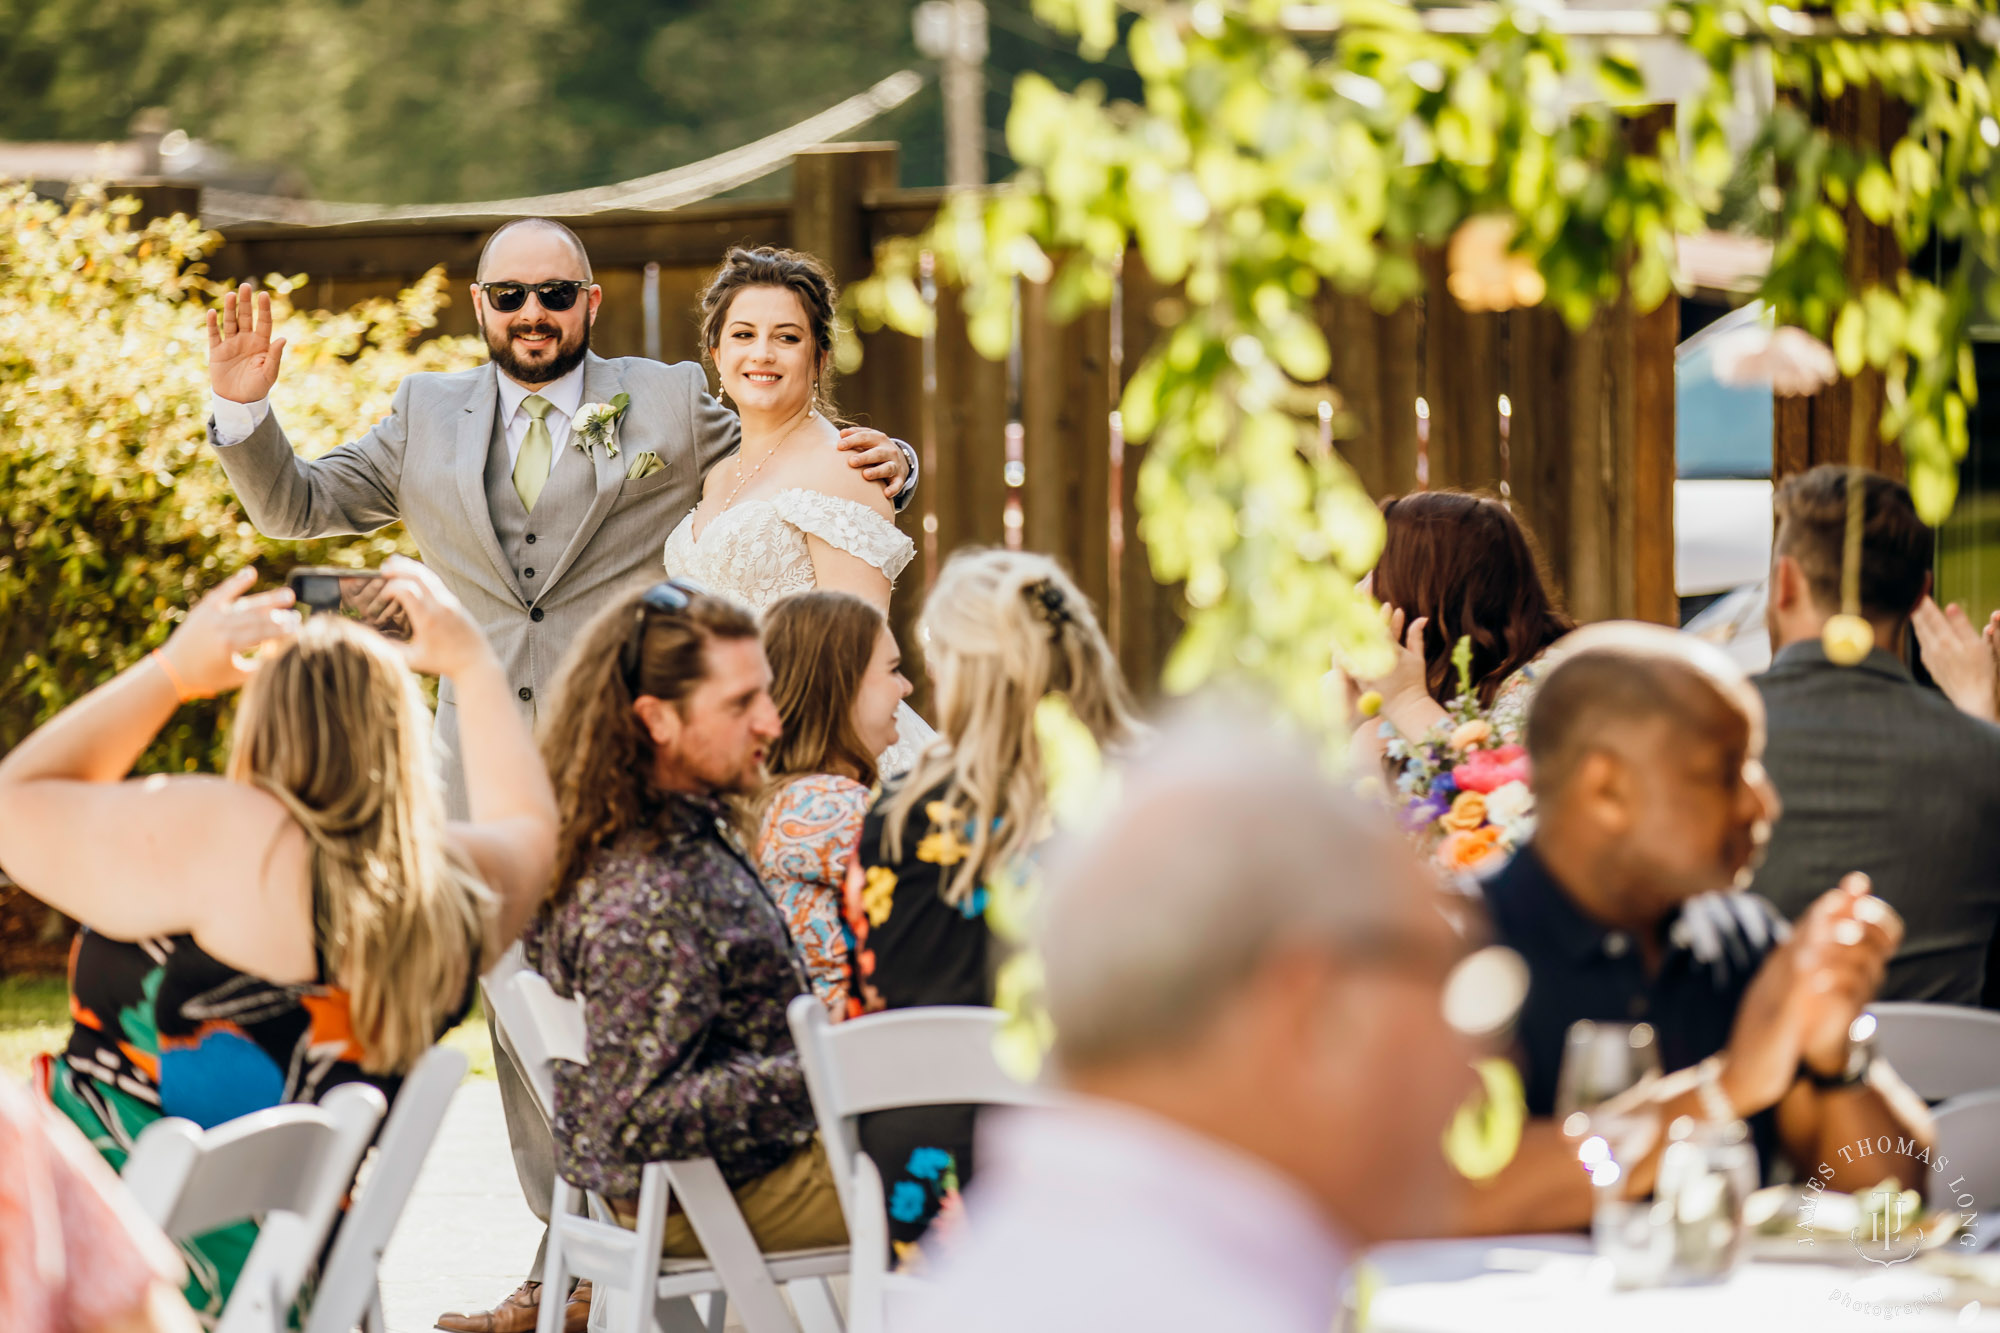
[666,488,916,610]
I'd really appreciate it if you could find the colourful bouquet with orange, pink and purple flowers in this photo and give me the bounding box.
[1384,638,1534,875]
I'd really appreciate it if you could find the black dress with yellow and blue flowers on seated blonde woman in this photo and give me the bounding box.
[844,785,996,1257]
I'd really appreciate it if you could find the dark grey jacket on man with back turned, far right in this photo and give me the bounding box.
[1754,642,2000,1005]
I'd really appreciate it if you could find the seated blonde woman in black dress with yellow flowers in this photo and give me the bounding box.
[846,550,1134,1243]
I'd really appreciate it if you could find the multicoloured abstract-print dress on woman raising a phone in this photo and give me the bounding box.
[36,927,476,1319]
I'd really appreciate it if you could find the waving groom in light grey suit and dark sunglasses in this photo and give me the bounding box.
[208,218,916,1333]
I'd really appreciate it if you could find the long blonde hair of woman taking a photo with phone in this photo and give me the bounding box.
[228,616,490,1075]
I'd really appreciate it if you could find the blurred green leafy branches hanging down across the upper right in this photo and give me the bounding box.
[852,0,2000,719]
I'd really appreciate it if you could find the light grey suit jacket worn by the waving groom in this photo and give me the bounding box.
[210,354,742,815]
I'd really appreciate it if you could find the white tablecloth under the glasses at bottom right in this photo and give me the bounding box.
[1364,1235,2000,1333]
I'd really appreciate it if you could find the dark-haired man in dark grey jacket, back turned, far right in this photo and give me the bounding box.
[1754,464,2000,1005]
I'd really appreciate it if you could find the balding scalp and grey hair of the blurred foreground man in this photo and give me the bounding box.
[1042,704,1420,1065]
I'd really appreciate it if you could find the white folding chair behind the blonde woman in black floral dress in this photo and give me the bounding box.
[786,995,1052,1333]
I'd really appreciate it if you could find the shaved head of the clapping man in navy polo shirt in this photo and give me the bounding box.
[1528,622,1778,919]
